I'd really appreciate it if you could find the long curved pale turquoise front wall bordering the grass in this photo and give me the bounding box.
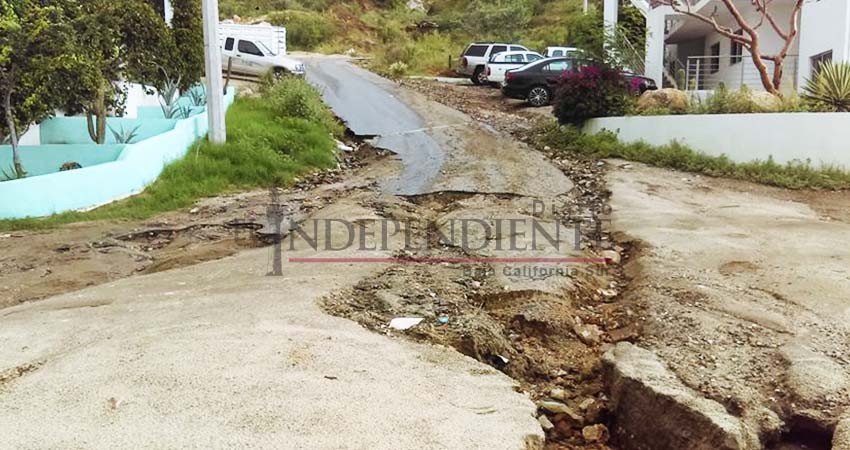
[0,88,236,219]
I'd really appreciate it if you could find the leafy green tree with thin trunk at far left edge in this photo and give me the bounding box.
[0,0,92,177]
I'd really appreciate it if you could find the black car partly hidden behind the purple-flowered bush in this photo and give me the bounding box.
[502,58,658,106]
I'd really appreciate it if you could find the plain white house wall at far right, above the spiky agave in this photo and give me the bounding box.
[797,0,850,86]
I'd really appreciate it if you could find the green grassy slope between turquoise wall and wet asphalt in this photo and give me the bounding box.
[0,79,342,231]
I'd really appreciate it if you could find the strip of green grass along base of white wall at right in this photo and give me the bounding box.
[531,122,850,190]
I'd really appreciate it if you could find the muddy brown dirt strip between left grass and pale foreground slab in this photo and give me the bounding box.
[0,146,374,308]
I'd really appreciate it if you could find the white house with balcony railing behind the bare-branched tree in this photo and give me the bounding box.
[605,0,850,90]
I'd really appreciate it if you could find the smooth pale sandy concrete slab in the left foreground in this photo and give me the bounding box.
[0,201,541,450]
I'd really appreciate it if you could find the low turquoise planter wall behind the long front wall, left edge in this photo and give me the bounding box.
[0,144,125,177]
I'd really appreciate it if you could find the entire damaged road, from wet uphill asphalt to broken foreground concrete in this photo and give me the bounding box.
[0,58,850,450]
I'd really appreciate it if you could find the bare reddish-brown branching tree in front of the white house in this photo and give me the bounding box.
[656,0,804,96]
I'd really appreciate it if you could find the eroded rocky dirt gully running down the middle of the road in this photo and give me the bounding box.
[314,72,641,449]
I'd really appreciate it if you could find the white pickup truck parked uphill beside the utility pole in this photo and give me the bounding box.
[219,23,305,77]
